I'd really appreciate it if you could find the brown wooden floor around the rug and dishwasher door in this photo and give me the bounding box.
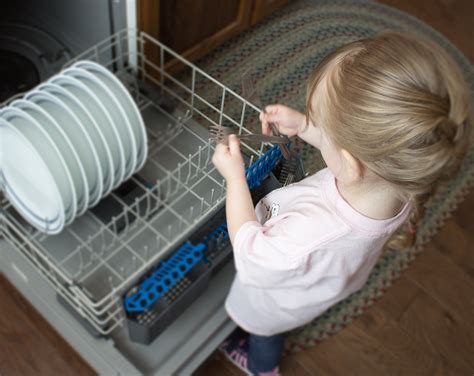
[0,0,474,376]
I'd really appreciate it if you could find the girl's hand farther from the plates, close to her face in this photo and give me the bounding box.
[260,104,306,137]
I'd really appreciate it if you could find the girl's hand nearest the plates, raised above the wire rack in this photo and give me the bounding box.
[212,135,246,181]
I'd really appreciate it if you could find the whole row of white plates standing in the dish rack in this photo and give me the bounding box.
[0,61,148,234]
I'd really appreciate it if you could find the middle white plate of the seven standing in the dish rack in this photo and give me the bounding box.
[38,83,106,207]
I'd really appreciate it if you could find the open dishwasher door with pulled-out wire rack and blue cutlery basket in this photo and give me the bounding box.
[0,30,296,375]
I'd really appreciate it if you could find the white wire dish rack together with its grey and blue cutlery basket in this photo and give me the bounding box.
[0,30,292,343]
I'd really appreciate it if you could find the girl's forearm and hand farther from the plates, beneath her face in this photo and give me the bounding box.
[260,104,321,149]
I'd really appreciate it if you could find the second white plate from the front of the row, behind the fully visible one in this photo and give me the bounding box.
[11,99,84,220]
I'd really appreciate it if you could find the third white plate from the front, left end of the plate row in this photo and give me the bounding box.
[25,86,101,215]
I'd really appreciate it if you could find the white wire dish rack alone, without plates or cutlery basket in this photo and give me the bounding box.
[0,30,280,335]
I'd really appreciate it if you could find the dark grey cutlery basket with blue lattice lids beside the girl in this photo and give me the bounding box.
[124,169,281,344]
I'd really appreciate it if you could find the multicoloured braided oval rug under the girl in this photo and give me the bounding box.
[193,0,474,352]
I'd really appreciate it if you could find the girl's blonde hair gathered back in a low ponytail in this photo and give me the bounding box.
[306,32,470,249]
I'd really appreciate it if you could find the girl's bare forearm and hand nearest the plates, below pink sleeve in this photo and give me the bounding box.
[212,135,257,244]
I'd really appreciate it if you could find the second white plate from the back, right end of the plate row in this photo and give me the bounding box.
[63,68,137,180]
